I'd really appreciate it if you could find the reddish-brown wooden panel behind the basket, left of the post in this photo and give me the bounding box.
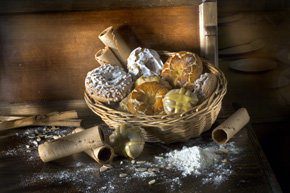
[0,6,199,101]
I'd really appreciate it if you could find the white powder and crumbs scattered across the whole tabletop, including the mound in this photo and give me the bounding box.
[0,127,241,190]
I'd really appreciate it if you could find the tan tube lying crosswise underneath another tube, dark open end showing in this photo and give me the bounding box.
[72,128,114,164]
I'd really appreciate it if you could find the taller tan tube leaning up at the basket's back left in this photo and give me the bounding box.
[99,26,132,66]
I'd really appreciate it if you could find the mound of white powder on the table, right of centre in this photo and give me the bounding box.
[158,142,241,185]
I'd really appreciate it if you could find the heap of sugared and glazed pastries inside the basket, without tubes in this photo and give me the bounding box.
[85,47,217,115]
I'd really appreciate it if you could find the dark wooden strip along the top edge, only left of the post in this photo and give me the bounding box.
[0,0,201,14]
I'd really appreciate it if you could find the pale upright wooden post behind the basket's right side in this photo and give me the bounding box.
[199,2,218,67]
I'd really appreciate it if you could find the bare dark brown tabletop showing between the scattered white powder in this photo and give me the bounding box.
[0,104,282,193]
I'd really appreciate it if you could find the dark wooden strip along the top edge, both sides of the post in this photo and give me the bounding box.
[0,0,290,14]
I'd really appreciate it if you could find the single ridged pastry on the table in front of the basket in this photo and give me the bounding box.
[109,124,145,159]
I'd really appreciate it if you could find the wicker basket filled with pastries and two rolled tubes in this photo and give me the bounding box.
[85,27,227,143]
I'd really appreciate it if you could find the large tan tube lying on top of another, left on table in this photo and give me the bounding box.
[38,126,104,162]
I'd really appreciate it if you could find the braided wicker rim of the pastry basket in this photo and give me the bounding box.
[84,58,227,121]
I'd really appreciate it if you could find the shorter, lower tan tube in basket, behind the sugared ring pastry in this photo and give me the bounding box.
[95,46,123,67]
